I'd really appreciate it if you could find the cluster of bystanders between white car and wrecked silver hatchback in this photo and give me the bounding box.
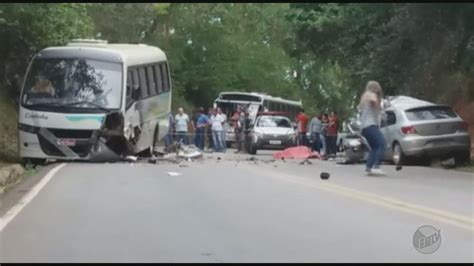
[296,109,339,159]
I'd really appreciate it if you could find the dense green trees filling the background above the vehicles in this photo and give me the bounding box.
[0,3,474,118]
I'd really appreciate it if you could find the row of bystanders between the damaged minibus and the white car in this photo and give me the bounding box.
[165,106,248,153]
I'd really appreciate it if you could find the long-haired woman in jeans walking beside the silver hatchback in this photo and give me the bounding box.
[359,81,385,175]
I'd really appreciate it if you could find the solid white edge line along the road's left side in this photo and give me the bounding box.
[0,163,66,232]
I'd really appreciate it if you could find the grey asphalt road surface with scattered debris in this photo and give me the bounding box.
[0,151,474,263]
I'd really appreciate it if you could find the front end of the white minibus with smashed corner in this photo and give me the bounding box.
[18,41,140,164]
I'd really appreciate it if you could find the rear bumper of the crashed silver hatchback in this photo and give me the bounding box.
[400,134,471,156]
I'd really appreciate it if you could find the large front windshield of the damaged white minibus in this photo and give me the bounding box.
[22,58,122,111]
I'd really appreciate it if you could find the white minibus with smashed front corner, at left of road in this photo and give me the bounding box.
[18,40,171,163]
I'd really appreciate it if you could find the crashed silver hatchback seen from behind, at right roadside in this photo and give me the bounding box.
[381,96,471,164]
